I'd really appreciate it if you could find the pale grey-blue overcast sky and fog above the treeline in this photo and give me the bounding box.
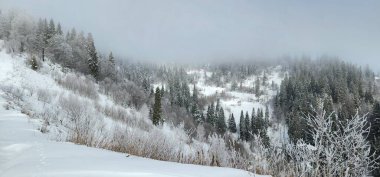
[0,0,380,70]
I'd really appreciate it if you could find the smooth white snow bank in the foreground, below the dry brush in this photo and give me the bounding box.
[0,97,268,177]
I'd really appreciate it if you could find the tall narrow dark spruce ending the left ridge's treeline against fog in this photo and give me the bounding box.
[86,33,99,79]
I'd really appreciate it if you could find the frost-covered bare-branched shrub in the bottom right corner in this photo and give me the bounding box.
[290,110,375,177]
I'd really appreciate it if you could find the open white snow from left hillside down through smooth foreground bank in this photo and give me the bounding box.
[0,41,268,177]
